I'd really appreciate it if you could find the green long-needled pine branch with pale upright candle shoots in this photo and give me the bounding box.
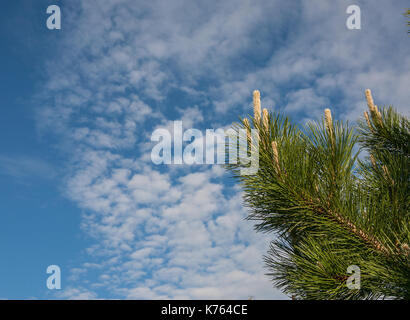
[227,90,410,299]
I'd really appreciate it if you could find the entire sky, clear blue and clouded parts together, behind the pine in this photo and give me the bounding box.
[0,0,410,299]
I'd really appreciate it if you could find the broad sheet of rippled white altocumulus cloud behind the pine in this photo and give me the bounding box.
[38,0,410,299]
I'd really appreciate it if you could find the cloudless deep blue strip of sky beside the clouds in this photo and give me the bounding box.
[0,0,87,299]
